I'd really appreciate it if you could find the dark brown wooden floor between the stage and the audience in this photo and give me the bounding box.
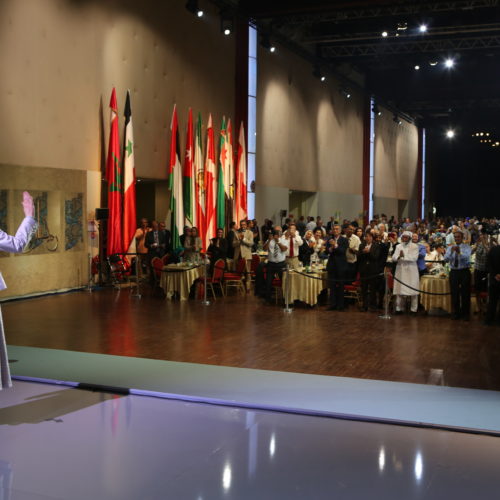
[2,289,500,390]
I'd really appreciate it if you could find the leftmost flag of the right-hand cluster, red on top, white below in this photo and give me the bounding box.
[168,106,184,249]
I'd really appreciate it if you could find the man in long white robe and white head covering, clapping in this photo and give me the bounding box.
[392,231,420,314]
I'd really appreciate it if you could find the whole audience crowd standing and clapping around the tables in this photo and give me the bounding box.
[131,214,500,324]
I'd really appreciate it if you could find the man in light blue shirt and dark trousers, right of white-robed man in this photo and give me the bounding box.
[444,229,472,321]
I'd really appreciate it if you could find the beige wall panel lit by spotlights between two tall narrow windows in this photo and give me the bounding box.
[256,48,363,194]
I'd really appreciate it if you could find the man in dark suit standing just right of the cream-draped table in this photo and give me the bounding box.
[326,224,349,311]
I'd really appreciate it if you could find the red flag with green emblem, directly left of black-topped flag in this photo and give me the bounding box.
[106,87,123,255]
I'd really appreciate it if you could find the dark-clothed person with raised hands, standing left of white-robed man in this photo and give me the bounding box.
[358,232,380,311]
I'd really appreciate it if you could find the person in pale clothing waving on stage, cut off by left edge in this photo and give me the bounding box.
[0,191,36,390]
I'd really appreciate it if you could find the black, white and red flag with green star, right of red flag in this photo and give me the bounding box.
[123,90,137,253]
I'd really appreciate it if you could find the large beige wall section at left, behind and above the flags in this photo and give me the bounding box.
[0,0,235,178]
